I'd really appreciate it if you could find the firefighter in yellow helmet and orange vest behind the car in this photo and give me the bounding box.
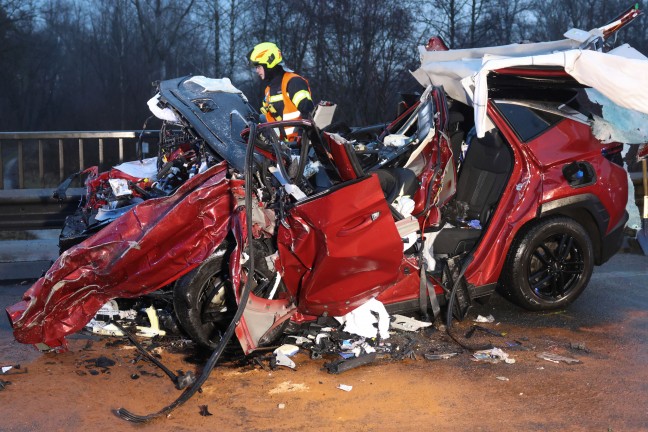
[248,42,315,141]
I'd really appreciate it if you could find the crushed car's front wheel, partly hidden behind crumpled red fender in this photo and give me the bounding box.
[173,248,236,349]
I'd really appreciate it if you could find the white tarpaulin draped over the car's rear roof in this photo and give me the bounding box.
[413,40,648,137]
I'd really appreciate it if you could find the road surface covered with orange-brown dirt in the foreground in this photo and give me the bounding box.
[0,251,648,432]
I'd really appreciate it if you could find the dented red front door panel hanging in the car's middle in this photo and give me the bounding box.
[278,175,403,316]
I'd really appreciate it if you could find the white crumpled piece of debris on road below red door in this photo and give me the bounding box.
[335,299,389,339]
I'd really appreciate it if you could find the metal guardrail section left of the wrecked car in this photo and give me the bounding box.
[0,131,159,231]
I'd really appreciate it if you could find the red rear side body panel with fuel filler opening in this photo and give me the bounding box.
[465,98,627,286]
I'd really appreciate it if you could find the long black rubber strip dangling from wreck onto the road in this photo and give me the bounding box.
[115,123,256,423]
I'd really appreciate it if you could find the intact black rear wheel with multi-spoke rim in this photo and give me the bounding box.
[502,217,594,311]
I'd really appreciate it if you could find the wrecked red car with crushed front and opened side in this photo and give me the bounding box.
[7,7,644,364]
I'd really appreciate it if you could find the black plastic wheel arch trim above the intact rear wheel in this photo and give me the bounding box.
[536,194,610,265]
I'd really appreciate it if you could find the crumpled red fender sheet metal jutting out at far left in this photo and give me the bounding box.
[7,163,232,349]
